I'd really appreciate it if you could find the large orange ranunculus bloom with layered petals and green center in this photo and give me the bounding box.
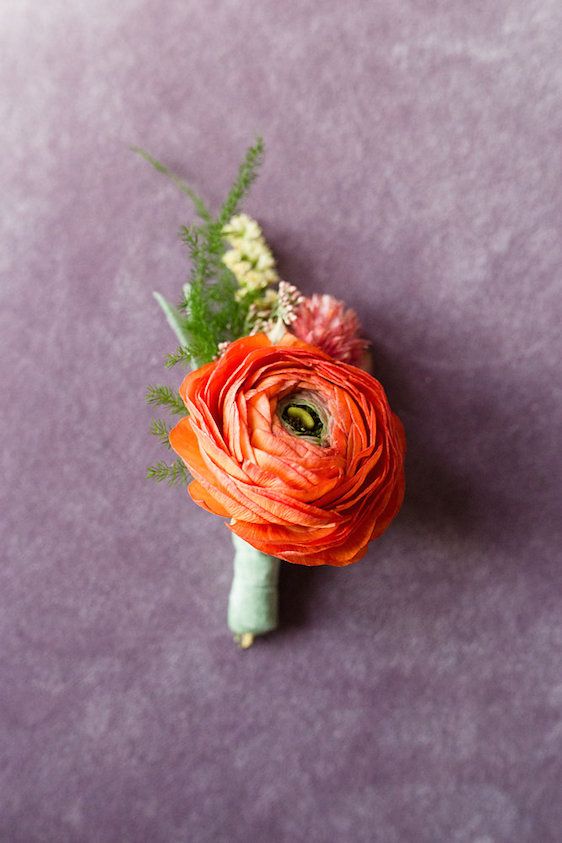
[170,334,406,565]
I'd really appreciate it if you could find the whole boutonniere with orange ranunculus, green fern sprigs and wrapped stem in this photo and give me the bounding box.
[136,139,405,648]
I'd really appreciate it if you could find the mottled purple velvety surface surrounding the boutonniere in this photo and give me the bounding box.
[0,0,562,843]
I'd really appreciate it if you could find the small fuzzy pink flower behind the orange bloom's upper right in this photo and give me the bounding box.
[290,293,369,365]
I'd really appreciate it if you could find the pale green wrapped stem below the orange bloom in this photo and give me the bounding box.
[228,535,280,650]
